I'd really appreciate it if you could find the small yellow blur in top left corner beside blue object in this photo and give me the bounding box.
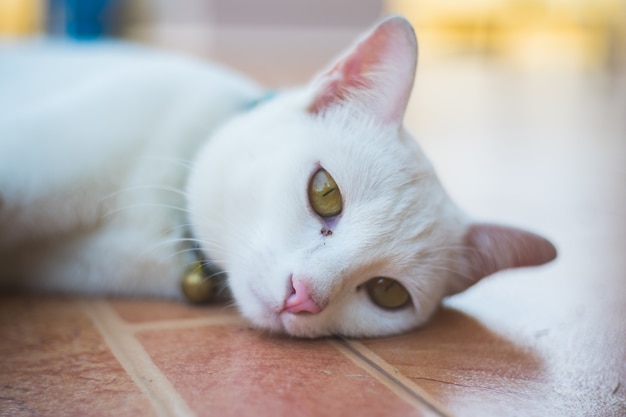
[0,0,44,36]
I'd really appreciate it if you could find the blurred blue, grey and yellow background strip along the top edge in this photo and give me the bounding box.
[0,0,626,75]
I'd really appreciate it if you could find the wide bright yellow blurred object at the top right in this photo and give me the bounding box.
[387,0,626,68]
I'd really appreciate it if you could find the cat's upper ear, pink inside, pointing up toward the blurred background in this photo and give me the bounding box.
[309,16,417,124]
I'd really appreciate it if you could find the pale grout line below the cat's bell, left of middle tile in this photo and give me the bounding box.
[79,300,195,417]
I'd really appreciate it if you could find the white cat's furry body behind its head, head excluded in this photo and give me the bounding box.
[0,42,261,297]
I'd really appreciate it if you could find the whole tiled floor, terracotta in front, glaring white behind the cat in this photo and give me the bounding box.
[0,26,626,417]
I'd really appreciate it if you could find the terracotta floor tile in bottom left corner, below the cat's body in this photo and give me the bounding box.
[0,295,154,417]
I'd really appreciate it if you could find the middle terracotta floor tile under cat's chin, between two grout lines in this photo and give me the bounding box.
[137,326,432,417]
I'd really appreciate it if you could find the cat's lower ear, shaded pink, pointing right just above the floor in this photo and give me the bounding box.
[464,224,557,282]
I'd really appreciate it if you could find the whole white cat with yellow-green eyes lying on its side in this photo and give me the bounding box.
[0,17,556,337]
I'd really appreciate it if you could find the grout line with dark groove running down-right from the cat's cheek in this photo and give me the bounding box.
[328,337,453,417]
